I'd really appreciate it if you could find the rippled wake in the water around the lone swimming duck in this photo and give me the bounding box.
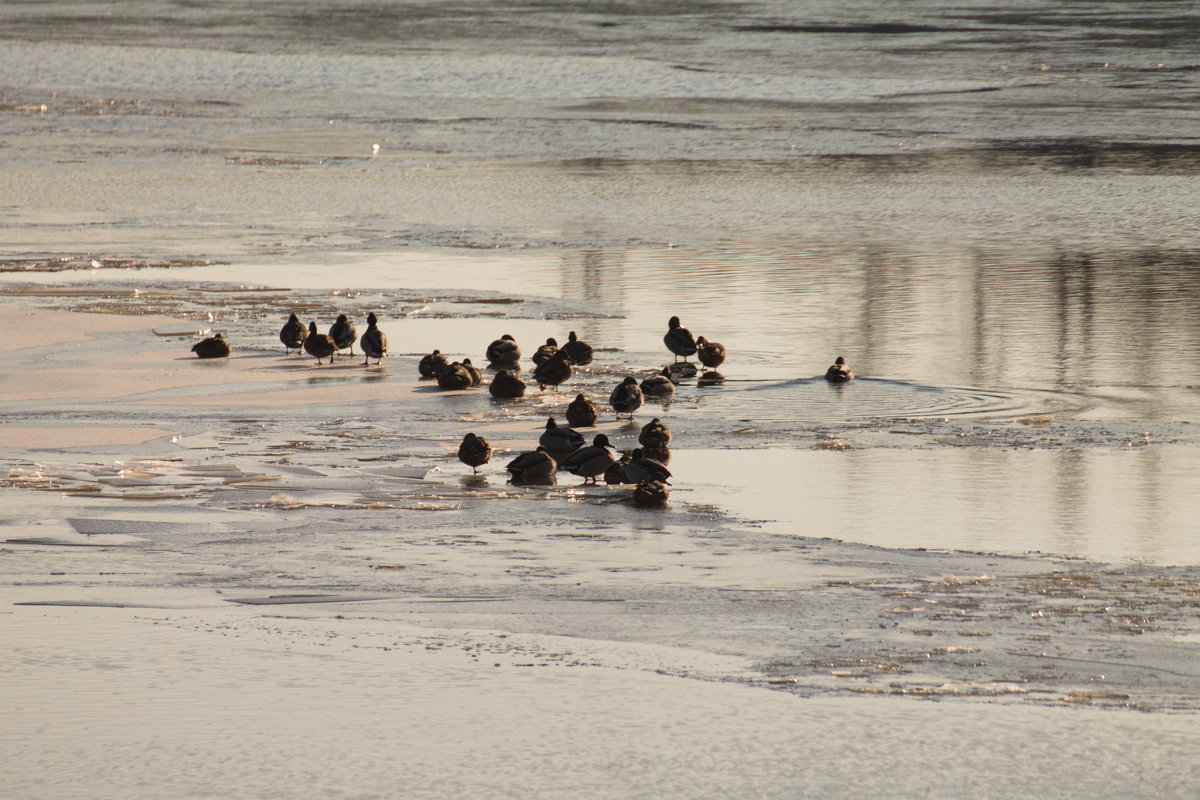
[702,378,1097,423]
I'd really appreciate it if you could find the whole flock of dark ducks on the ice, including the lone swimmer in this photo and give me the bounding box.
[192,312,854,507]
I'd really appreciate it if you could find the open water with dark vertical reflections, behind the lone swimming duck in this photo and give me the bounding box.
[559,242,1200,410]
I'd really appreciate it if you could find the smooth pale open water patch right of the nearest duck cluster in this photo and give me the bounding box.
[671,449,1200,564]
